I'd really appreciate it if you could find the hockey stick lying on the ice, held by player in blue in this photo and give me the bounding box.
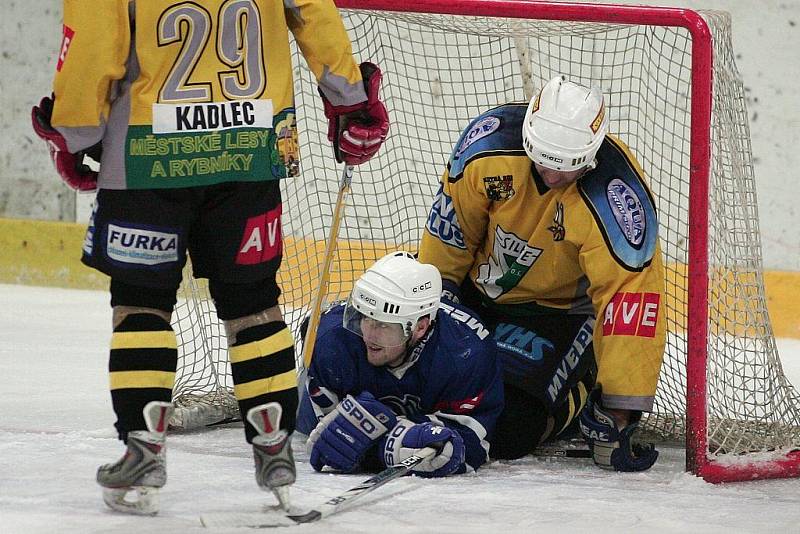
[200,447,436,528]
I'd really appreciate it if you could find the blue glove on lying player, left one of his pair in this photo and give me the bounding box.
[306,391,397,473]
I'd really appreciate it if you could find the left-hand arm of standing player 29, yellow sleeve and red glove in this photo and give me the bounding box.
[31,0,131,191]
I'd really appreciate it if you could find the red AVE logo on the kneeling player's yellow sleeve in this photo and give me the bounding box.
[603,293,661,337]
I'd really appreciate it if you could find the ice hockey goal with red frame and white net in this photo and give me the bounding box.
[169,0,800,481]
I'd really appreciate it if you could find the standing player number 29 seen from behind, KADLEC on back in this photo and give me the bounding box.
[33,0,389,514]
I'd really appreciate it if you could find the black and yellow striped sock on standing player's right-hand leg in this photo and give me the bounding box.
[229,321,297,443]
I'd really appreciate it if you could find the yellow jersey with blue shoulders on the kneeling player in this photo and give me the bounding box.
[419,104,666,411]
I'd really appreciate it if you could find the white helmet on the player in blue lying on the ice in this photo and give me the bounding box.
[342,251,442,345]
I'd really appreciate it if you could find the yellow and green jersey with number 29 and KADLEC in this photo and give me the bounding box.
[52,0,366,189]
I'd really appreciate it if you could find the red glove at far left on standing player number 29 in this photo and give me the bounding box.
[31,96,103,192]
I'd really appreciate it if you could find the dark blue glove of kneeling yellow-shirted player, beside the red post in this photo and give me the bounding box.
[580,387,658,471]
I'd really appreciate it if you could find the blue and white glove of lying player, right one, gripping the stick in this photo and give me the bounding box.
[382,419,466,477]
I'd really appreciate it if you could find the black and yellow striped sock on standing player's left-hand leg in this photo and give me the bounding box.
[108,313,178,441]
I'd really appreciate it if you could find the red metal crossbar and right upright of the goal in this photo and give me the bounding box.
[336,0,720,478]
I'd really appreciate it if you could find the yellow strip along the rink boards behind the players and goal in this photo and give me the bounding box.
[0,218,800,339]
